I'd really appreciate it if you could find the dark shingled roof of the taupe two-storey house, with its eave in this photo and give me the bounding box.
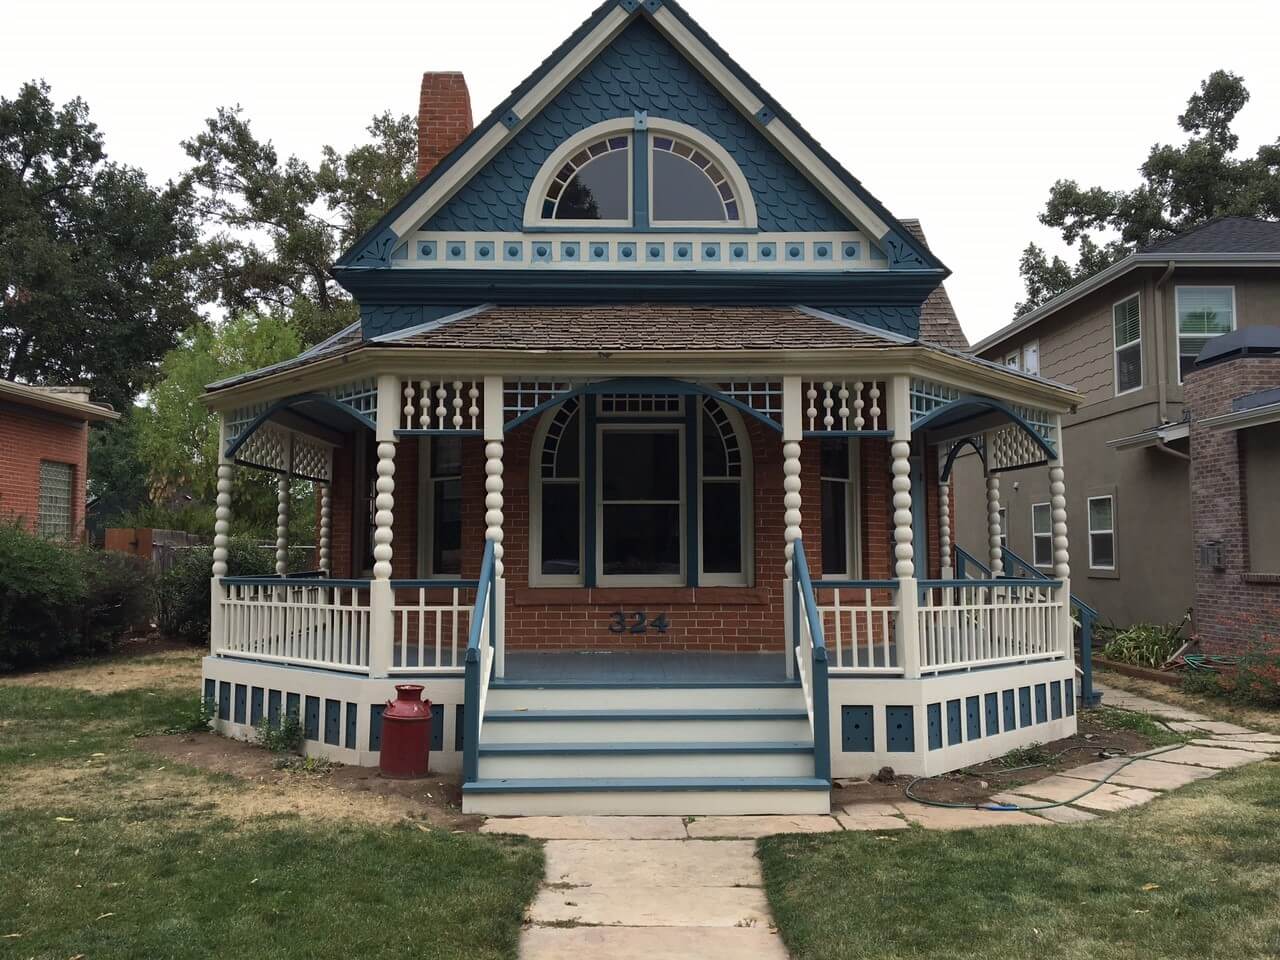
[973,216,1280,353]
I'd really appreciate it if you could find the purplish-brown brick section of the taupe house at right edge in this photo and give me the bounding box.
[1184,357,1280,652]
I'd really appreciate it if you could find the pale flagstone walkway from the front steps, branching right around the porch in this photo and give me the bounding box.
[481,687,1280,960]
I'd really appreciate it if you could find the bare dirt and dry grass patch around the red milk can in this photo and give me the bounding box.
[134,733,484,829]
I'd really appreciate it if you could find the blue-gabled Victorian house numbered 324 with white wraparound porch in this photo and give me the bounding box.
[204,0,1079,814]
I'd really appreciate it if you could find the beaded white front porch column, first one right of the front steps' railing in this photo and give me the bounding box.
[888,376,920,678]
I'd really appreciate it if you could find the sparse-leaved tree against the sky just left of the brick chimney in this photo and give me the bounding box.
[183,106,417,343]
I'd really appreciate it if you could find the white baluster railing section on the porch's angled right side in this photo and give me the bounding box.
[918,580,1068,673]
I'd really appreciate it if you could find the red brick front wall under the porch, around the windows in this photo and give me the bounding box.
[320,421,940,652]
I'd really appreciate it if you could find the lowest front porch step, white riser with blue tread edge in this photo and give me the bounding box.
[462,777,831,817]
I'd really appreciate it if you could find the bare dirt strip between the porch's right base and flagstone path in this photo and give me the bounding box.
[831,713,1172,806]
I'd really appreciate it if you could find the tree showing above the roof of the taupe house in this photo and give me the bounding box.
[1016,70,1280,316]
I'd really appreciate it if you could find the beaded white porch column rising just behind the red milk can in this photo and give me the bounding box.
[369,374,401,677]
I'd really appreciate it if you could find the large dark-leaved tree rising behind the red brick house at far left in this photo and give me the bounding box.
[0,82,198,408]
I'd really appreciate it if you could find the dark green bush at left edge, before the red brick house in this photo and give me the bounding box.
[0,522,151,671]
